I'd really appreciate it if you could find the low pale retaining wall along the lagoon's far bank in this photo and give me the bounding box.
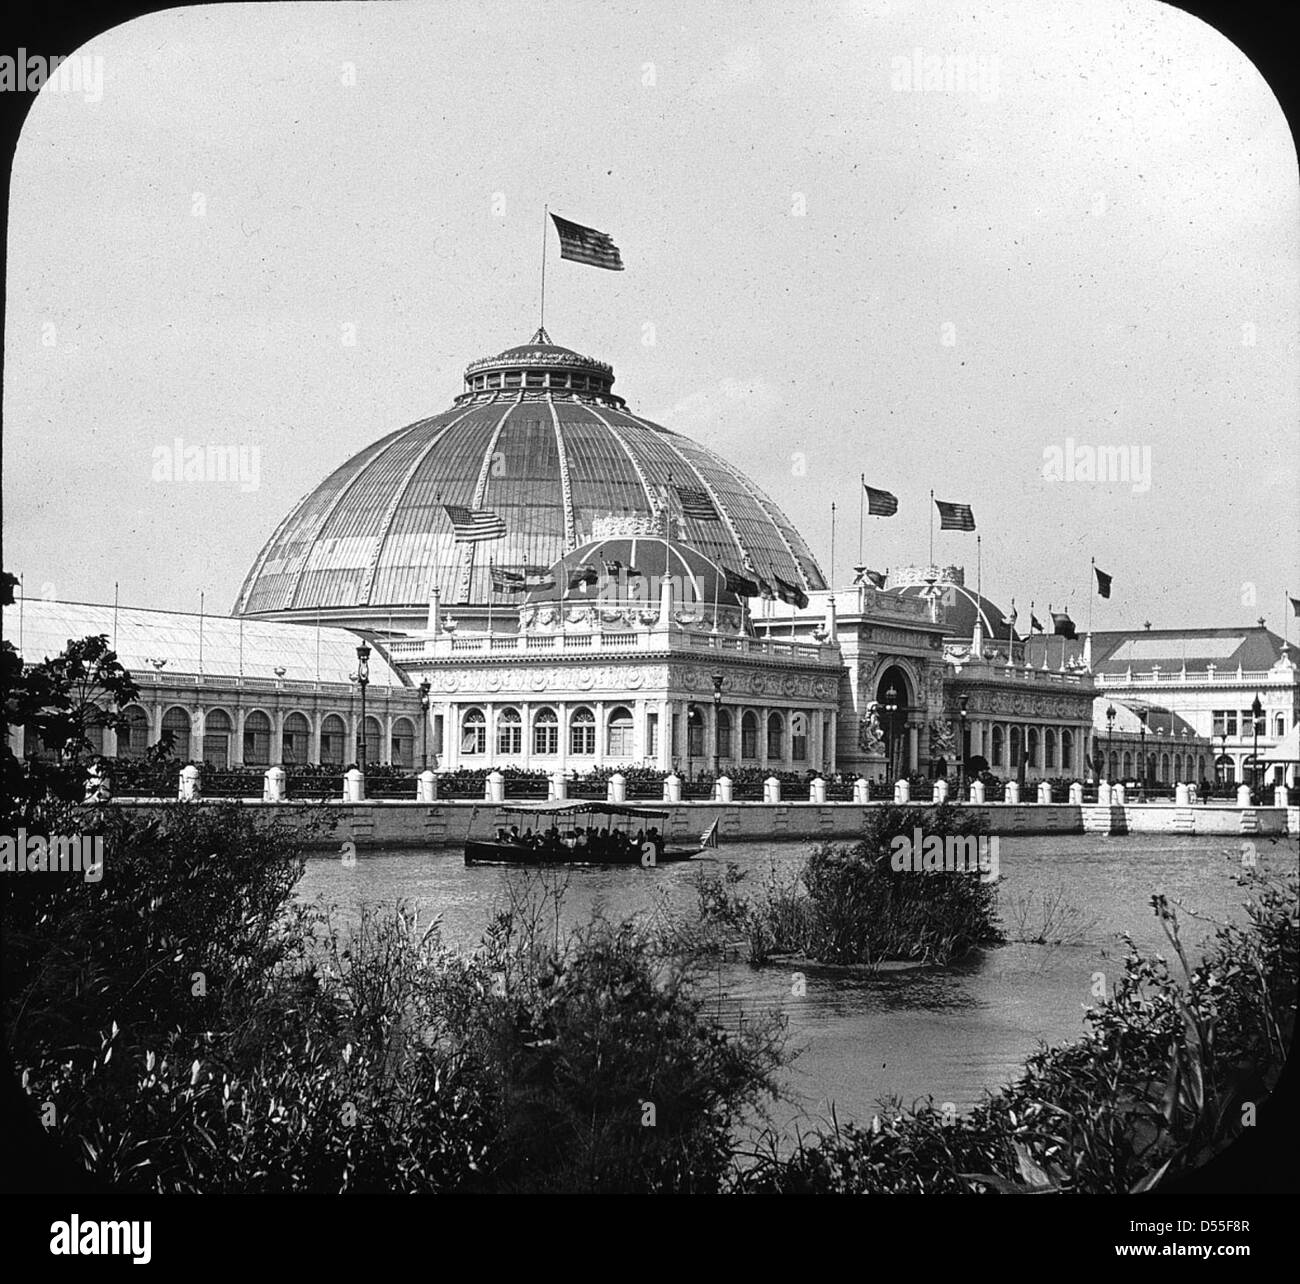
[106,798,1300,851]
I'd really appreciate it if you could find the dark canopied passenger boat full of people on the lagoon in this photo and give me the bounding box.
[465,802,718,869]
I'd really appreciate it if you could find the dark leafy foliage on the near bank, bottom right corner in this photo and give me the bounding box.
[737,873,1297,1194]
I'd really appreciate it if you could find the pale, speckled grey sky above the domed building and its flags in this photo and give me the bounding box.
[4,0,1300,639]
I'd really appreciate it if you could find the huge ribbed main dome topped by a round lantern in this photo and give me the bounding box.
[234,330,826,620]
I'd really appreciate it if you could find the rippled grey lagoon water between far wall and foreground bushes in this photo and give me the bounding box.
[299,834,1300,1129]
